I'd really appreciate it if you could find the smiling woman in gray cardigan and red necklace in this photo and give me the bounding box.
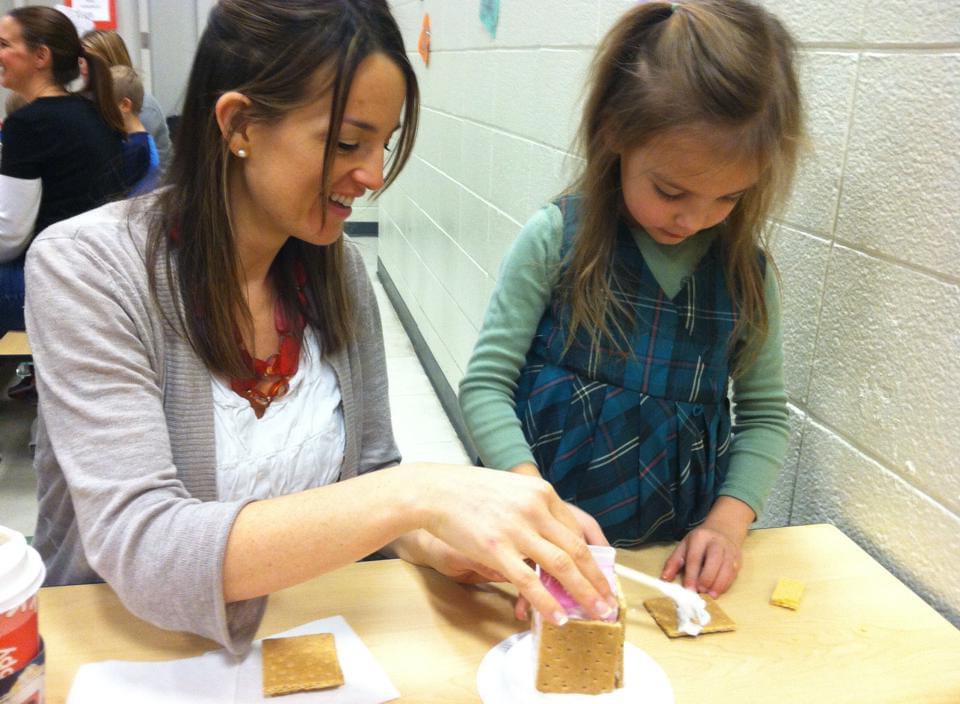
[27,0,611,652]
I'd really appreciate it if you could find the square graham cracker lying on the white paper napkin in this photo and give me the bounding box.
[263,633,343,697]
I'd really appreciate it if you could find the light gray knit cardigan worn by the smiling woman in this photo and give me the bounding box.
[26,196,400,653]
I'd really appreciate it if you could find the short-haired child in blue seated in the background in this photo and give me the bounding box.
[110,66,160,196]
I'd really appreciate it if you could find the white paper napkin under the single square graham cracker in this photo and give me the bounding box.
[67,616,400,704]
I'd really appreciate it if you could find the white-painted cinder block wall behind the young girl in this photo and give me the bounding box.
[379,0,960,625]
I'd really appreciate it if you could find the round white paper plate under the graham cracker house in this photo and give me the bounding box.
[477,631,674,704]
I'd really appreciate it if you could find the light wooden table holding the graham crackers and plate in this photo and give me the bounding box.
[40,525,960,704]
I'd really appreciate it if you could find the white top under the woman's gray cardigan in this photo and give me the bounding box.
[211,327,345,501]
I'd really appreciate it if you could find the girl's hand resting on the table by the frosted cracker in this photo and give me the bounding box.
[660,496,756,598]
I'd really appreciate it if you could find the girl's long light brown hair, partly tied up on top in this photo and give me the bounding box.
[560,0,803,375]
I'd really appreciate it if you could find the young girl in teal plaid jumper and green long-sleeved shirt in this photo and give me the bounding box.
[460,0,802,596]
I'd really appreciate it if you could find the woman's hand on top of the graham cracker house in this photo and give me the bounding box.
[409,465,615,623]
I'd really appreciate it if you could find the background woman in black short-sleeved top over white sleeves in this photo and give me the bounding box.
[0,7,124,333]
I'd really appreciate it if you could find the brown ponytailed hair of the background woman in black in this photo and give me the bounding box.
[8,6,127,135]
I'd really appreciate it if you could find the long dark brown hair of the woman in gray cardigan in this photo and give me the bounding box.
[148,0,419,377]
